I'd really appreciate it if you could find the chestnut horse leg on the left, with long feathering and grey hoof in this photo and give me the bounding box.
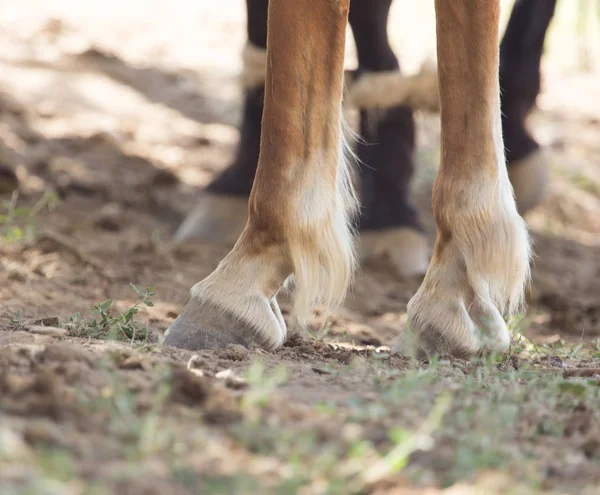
[165,0,356,349]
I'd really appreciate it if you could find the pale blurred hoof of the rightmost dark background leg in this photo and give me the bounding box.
[508,150,550,215]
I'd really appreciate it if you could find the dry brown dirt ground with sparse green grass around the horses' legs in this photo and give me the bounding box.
[0,0,600,495]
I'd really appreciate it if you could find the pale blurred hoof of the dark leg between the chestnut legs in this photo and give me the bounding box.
[359,228,430,278]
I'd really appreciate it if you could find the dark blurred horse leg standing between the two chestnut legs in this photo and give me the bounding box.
[349,0,429,276]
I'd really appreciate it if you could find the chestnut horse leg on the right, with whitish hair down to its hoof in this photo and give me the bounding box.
[394,0,530,356]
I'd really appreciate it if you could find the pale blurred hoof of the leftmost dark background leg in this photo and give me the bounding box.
[173,195,248,245]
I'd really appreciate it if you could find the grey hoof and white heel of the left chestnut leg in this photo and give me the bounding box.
[163,297,286,351]
